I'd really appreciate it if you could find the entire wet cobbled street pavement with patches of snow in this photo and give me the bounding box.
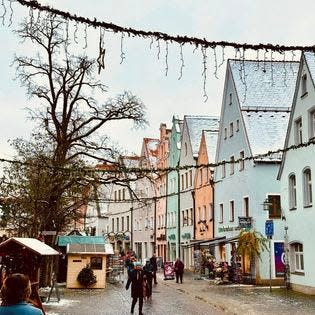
[40,272,315,315]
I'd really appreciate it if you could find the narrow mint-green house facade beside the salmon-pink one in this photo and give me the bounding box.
[166,116,183,261]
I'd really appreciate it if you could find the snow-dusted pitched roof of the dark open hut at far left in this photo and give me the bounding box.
[0,237,59,256]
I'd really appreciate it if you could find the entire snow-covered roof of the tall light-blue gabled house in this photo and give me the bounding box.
[229,60,299,161]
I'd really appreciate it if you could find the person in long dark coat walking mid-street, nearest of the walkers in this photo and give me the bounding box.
[126,262,144,315]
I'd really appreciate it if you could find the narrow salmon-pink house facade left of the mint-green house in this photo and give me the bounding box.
[155,124,171,261]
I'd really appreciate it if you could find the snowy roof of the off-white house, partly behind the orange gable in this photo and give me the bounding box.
[184,115,219,157]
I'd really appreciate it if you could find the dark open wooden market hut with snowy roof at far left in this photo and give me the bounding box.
[0,237,59,311]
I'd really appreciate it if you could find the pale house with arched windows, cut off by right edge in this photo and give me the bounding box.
[278,52,315,294]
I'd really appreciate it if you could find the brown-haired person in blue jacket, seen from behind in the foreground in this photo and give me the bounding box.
[0,273,44,315]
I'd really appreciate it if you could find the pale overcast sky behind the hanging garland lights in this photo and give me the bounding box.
[0,0,315,158]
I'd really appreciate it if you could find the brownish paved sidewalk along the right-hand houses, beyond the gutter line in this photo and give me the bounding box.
[158,272,315,315]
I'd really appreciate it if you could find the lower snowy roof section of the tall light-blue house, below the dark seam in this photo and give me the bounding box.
[242,111,290,160]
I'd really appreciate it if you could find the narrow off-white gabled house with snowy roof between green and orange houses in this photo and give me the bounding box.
[179,115,219,269]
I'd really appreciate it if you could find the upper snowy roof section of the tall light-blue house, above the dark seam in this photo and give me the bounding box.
[229,60,299,108]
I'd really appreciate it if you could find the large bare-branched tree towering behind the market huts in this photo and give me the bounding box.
[1,15,146,236]
